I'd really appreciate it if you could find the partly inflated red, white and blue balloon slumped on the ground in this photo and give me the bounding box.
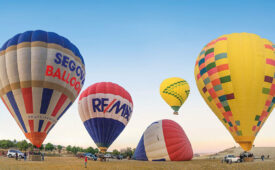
[134,119,193,161]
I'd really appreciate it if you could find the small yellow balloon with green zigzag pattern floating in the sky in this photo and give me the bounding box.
[160,77,190,115]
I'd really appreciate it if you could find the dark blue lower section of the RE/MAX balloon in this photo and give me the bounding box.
[84,118,125,148]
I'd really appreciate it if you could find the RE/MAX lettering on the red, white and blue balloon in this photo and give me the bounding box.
[92,98,132,121]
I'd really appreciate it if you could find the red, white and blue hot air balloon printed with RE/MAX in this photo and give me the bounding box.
[78,82,133,153]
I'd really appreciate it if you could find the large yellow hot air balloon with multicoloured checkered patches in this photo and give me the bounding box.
[195,33,275,151]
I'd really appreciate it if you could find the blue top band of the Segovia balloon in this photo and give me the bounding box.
[0,30,85,65]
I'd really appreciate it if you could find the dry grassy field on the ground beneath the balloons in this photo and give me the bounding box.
[0,157,275,170]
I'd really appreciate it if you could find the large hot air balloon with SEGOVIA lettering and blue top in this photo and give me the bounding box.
[0,30,85,147]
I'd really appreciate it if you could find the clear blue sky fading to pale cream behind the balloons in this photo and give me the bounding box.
[0,0,275,152]
